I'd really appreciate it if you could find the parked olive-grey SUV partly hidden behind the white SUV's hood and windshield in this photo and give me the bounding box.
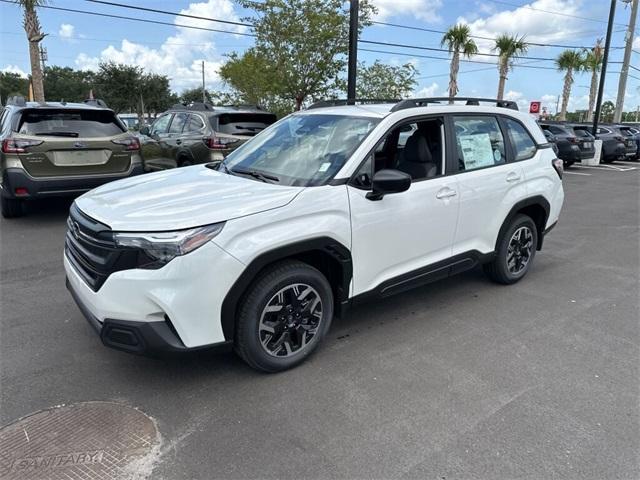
[140,103,276,171]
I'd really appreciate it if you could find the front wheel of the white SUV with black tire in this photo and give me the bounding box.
[234,260,333,373]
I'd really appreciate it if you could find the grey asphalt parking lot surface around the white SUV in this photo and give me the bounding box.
[0,163,640,480]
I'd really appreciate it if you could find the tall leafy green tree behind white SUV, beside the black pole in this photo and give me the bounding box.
[234,0,375,110]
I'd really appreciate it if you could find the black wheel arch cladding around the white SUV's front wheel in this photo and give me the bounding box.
[221,237,353,341]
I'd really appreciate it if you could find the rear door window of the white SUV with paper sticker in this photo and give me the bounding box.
[453,115,507,172]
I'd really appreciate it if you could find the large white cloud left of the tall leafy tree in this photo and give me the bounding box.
[76,0,244,91]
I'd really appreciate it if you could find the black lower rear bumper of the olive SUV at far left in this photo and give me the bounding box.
[1,164,144,198]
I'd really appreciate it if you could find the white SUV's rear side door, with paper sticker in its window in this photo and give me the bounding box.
[449,114,527,256]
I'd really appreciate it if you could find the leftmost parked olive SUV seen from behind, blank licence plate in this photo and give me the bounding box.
[0,97,143,217]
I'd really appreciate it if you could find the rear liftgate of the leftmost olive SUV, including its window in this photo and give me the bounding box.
[14,108,131,177]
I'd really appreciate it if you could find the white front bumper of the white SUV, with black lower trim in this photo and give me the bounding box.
[64,242,244,354]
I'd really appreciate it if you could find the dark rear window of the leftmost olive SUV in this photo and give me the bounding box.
[16,108,125,138]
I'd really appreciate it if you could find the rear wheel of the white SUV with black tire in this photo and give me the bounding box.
[483,214,538,285]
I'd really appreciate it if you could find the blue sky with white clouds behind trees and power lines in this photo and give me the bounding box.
[0,0,640,112]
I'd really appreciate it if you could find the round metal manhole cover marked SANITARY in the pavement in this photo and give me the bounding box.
[0,402,160,480]
